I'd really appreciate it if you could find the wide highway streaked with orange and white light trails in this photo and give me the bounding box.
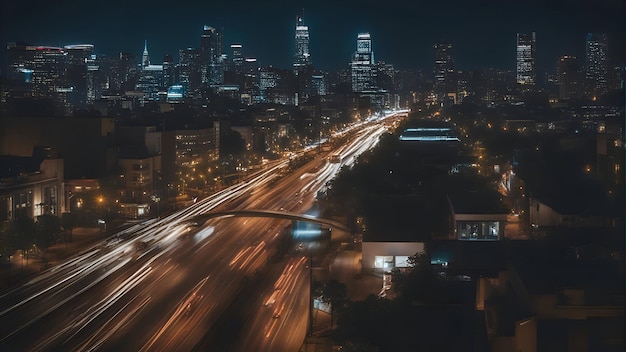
[0,110,402,351]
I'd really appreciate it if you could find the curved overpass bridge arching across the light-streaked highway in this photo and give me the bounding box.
[189,210,350,232]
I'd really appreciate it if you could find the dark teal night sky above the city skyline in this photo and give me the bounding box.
[0,0,626,71]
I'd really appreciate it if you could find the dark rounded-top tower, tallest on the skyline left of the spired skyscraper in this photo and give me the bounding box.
[200,26,224,87]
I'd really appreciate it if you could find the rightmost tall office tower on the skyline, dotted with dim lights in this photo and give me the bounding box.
[585,33,608,96]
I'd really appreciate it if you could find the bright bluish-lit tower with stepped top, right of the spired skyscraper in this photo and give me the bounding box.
[350,33,376,92]
